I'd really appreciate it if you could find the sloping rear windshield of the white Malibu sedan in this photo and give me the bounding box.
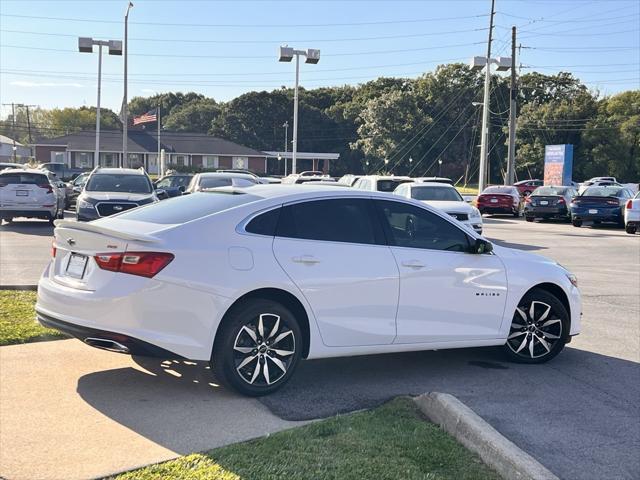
[118,191,262,225]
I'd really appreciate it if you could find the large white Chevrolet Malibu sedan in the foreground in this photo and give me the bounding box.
[36,185,581,395]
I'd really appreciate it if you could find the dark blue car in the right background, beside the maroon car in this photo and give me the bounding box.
[570,186,633,227]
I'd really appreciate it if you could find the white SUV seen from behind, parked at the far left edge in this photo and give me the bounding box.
[0,169,65,224]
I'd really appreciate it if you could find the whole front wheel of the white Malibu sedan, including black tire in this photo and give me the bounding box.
[503,288,570,364]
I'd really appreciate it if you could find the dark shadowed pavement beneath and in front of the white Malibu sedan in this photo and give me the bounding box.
[77,348,640,478]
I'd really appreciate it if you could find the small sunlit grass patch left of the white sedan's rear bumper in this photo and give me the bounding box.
[0,290,67,345]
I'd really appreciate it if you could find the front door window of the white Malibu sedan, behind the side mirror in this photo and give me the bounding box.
[376,200,469,252]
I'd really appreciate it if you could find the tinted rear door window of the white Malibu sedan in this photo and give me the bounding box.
[276,198,383,245]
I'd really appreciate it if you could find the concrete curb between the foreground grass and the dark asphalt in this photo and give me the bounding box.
[414,392,559,480]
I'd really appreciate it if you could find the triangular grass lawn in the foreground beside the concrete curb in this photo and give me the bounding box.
[113,398,500,480]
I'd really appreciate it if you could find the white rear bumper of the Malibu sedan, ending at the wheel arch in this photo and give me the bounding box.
[36,267,229,360]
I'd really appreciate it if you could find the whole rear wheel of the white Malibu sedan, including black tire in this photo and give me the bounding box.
[211,299,303,397]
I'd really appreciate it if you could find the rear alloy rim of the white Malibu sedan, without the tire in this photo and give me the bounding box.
[233,313,296,386]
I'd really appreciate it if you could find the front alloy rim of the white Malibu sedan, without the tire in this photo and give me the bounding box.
[507,300,562,359]
